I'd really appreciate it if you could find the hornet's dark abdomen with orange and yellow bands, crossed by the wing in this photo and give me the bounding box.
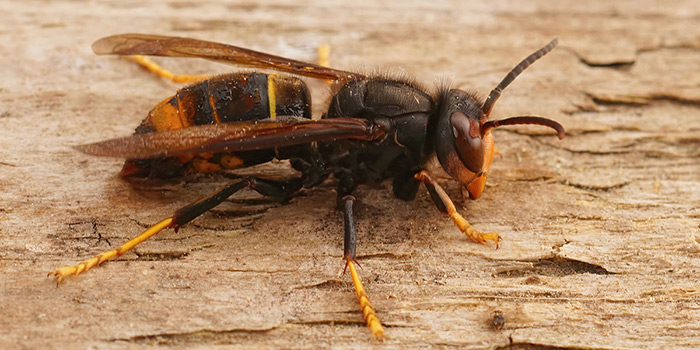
[122,72,311,178]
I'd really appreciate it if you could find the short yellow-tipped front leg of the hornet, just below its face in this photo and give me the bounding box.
[415,171,499,248]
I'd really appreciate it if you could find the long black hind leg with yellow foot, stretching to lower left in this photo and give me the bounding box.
[49,177,301,283]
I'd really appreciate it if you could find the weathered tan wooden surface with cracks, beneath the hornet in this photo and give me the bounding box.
[0,0,700,349]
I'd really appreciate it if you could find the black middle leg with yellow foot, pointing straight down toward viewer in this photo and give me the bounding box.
[343,196,384,338]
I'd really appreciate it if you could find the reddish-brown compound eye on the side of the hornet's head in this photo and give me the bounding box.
[450,112,484,175]
